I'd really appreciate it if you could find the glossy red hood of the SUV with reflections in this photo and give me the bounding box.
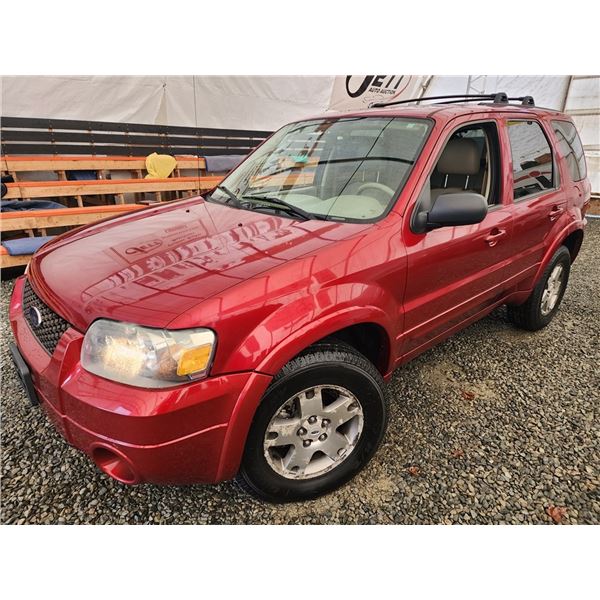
[29,198,366,331]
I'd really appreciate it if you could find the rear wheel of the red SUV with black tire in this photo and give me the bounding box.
[508,246,571,331]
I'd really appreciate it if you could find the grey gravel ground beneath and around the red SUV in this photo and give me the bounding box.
[1,221,600,524]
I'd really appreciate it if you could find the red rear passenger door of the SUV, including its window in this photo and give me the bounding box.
[503,118,567,289]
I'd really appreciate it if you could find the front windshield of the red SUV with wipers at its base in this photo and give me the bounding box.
[210,117,431,221]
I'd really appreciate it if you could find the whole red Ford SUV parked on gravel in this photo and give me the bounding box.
[10,94,590,501]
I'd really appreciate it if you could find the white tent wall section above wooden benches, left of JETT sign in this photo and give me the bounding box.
[1,76,335,131]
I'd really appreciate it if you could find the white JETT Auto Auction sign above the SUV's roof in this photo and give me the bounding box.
[330,75,425,110]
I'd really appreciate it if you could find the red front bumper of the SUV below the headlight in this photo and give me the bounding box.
[10,278,271,484]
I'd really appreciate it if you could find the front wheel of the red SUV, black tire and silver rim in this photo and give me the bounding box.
[237,341,388,503]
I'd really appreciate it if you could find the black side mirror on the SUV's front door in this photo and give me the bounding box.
[415,192,488,232]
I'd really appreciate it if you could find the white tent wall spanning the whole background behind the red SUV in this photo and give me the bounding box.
[0,75,600,192]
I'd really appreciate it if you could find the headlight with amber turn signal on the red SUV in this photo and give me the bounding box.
[81,319,216,388]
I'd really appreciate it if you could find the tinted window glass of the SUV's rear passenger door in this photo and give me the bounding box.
[508,121,554,200]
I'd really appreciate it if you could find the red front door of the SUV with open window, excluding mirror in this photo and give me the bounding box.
[399,120,513,358]
